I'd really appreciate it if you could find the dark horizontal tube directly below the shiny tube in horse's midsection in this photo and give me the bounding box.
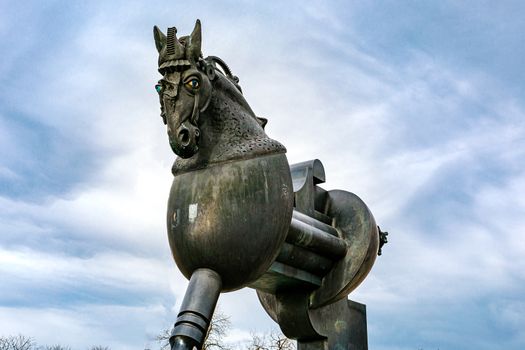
[276,242,333,277]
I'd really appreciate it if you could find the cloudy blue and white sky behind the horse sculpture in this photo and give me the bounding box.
[0,1,525,350]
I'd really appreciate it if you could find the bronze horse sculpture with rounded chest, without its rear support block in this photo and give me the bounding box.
[154,20,380,350]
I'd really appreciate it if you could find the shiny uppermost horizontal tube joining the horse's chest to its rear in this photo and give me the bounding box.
[286,217,346,260]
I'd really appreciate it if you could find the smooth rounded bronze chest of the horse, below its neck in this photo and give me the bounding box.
[167,153,293,291]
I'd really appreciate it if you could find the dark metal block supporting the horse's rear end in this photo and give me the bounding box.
[297,299,368,350]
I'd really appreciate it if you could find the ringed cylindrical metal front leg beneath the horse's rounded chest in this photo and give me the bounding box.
[170,269,222,350]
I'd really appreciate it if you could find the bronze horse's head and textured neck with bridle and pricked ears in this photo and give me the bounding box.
[153,20,286,174]
